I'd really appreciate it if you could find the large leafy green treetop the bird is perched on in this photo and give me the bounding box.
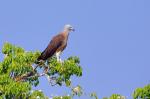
[0,43,82,99]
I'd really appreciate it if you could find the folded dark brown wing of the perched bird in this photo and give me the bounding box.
[37,34,64,60]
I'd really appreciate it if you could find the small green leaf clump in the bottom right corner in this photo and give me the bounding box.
[133,84,150,99]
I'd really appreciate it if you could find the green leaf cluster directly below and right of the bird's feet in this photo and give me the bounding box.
[47,57,82,86]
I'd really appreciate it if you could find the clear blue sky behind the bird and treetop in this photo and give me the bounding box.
[0,0,150,99]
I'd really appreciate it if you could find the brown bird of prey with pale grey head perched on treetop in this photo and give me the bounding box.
[37,24,75,62]
